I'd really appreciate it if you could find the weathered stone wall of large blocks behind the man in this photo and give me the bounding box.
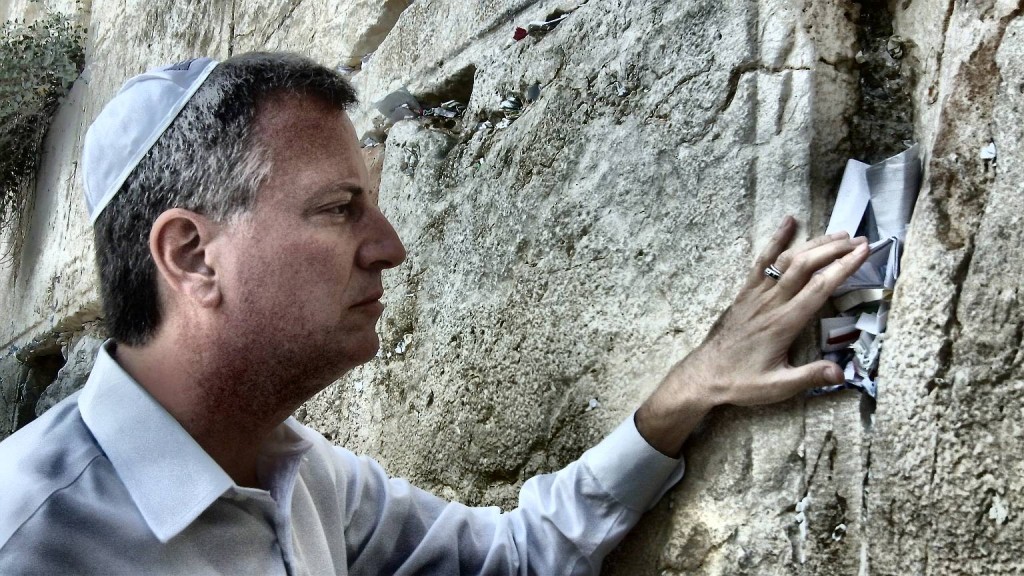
[0,0,1024,574]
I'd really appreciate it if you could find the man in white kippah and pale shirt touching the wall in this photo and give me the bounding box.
[0,54,866,574]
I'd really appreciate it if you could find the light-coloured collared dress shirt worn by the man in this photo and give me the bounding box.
[0,341,683,575]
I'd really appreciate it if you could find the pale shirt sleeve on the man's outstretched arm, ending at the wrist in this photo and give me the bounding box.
[336,415,683,574]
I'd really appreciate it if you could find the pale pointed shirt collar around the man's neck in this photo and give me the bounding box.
[78,340,308,542]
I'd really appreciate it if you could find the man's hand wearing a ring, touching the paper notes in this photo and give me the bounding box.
[636,216,867,457]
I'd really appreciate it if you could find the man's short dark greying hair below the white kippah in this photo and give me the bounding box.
[93,52,356,345]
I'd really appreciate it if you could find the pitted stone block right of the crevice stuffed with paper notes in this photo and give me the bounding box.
[868,2,1024,574]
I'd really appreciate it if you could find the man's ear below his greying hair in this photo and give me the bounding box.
[150,208,222,307]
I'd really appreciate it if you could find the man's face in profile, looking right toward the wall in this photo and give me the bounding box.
[217,95,406,381]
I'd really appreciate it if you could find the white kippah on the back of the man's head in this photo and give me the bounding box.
[82,58,217,223]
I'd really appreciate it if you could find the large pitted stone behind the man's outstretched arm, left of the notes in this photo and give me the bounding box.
[303,0,864,574]
